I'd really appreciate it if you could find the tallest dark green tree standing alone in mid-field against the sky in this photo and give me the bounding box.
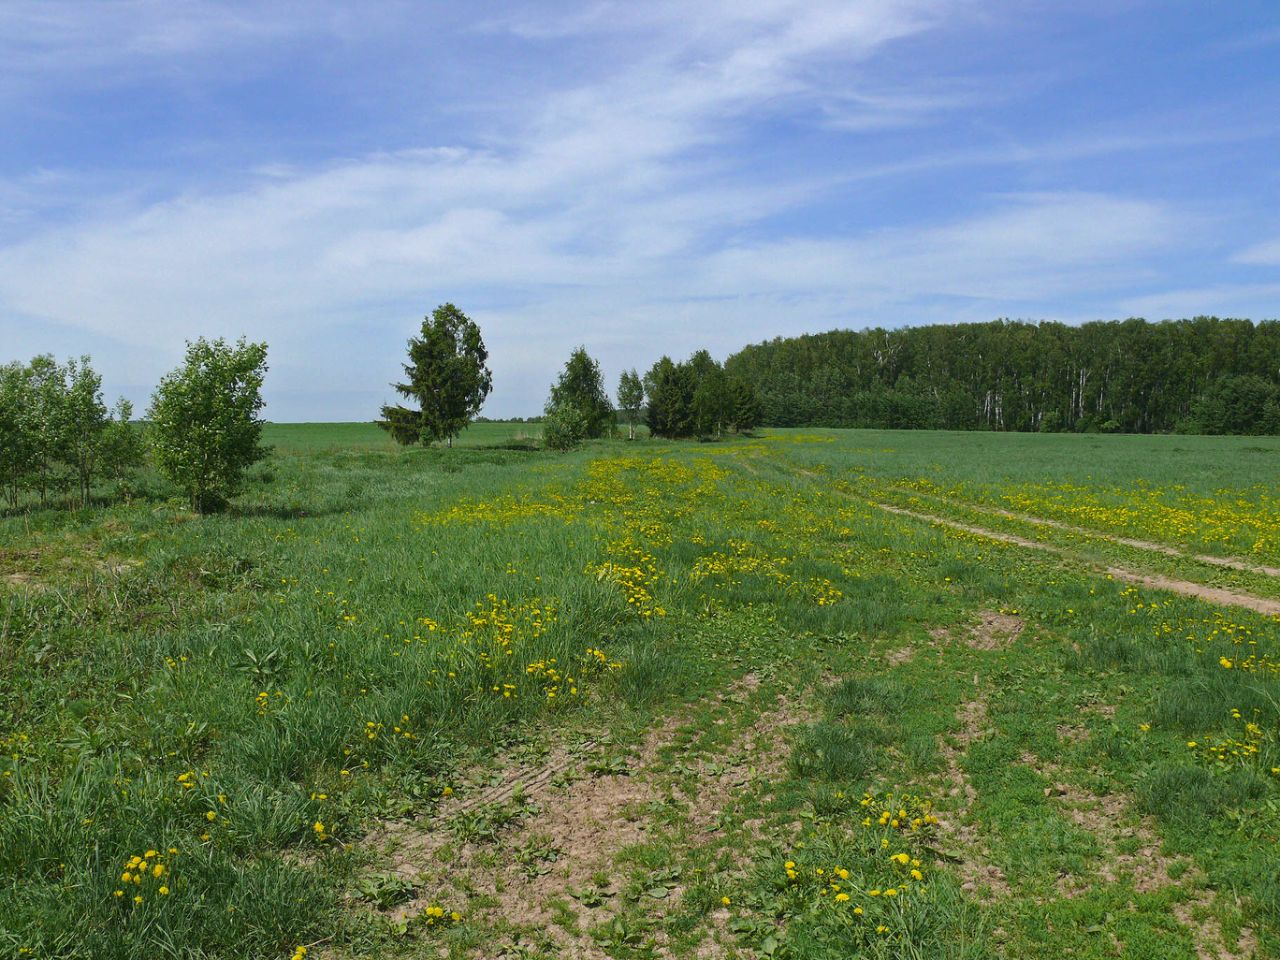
[378,303,493,447]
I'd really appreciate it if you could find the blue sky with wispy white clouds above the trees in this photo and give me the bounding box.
[0,0,1280,421]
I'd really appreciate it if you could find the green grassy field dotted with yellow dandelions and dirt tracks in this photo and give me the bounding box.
[0,424,1280,960]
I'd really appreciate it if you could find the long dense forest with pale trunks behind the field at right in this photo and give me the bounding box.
[724,316,1280,434]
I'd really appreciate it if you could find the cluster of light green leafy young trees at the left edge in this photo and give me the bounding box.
[0,338,266,512]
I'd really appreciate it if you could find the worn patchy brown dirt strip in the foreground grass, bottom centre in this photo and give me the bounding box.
[360,675,797,957]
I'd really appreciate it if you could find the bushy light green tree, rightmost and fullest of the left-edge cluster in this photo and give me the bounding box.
[147,337,266,512]
